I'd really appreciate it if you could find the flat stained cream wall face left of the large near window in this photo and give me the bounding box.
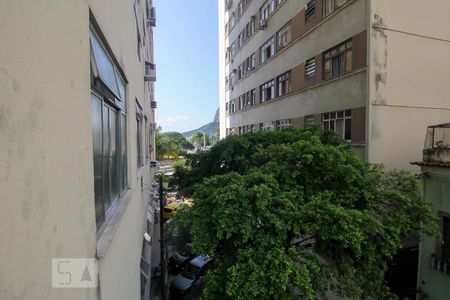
[0,1,98,300]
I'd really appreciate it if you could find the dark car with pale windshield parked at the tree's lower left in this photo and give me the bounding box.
[170,256,211,299]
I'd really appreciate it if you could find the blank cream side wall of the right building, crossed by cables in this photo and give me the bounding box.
[367,0,450,170]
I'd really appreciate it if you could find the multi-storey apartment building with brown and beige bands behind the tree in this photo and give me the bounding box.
[219,0,450,170]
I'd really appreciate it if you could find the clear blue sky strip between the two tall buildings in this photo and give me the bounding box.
[153,0,219,132]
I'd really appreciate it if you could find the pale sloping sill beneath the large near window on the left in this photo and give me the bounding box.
[97,189,134,259]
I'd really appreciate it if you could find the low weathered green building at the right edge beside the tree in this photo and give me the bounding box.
[413,123,450,300]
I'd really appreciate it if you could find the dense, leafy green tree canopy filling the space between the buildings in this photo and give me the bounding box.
[175,128,436,299]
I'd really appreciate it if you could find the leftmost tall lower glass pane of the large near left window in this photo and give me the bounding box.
[91,95,105,229]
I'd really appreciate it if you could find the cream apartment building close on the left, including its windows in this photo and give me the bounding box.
[0,0,156,300]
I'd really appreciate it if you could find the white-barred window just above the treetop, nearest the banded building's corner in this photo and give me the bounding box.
[322,109,352,141]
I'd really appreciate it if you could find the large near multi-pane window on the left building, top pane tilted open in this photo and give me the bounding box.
[89,29,128,230]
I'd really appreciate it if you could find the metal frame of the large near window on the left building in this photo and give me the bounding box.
[89,24,129,236]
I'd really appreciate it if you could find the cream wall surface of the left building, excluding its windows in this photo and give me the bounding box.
[0,0,154,300]
